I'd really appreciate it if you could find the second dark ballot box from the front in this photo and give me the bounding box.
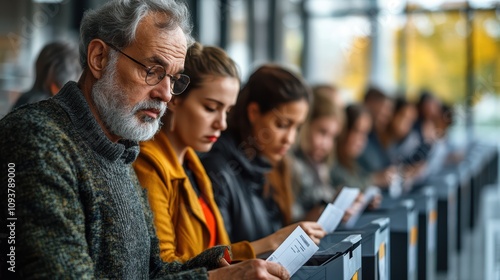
[326,218,391,280]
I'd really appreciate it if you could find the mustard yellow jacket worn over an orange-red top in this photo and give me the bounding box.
[134,132,255,262]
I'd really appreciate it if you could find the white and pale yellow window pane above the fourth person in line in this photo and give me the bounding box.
[307,16,372,102]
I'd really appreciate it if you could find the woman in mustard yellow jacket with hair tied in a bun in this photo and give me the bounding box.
[134,44,322,261]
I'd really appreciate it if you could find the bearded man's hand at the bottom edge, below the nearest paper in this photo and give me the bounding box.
[208,259,290,280]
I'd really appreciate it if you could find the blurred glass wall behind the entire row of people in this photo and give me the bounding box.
[0,0,500,144]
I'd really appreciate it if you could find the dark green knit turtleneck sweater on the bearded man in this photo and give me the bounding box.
[0,82,227,280]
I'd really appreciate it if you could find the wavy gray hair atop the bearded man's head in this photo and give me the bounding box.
[80,0,194,69]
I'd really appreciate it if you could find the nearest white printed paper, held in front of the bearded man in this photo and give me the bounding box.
[267,226,319,276]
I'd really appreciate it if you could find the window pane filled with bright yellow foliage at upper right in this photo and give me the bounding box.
[404,12,467,104]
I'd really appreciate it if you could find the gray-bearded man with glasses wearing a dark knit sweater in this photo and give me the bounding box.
[0,0,288,279]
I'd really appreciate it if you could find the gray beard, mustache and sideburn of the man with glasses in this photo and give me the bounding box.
[91,52,166,141]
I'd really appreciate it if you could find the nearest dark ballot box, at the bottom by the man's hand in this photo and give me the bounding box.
[292,234,362,280]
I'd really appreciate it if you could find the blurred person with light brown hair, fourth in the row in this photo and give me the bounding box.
[292,88,343,220]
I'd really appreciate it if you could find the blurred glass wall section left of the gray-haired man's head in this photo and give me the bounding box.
[0,0,78,115]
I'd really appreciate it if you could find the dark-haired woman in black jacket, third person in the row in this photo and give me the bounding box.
[202,65,325,245]
